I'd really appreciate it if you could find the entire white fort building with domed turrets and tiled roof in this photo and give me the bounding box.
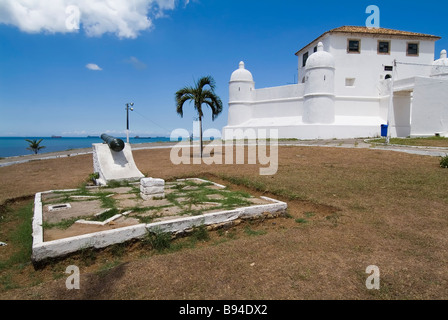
[223,26,448,139]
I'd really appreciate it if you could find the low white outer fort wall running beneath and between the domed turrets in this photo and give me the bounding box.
[223,79,389,139]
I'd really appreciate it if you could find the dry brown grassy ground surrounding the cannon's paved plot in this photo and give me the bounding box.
[0,147,448,300]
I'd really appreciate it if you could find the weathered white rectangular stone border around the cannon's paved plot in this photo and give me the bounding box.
[31,180,288,264]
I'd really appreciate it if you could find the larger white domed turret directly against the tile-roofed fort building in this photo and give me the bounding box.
[302,42,335,124]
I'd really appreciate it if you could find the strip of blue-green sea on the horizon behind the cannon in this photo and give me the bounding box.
[0,136,170,158]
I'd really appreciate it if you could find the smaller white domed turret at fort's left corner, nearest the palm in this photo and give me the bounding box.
[228,61,255,126]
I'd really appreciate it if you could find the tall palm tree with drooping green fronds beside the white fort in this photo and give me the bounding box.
[176,76,222,158]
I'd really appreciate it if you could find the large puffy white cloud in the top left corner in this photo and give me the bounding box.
[0,0,189,38]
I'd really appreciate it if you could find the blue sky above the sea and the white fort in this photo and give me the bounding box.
[0,0,448,136]
